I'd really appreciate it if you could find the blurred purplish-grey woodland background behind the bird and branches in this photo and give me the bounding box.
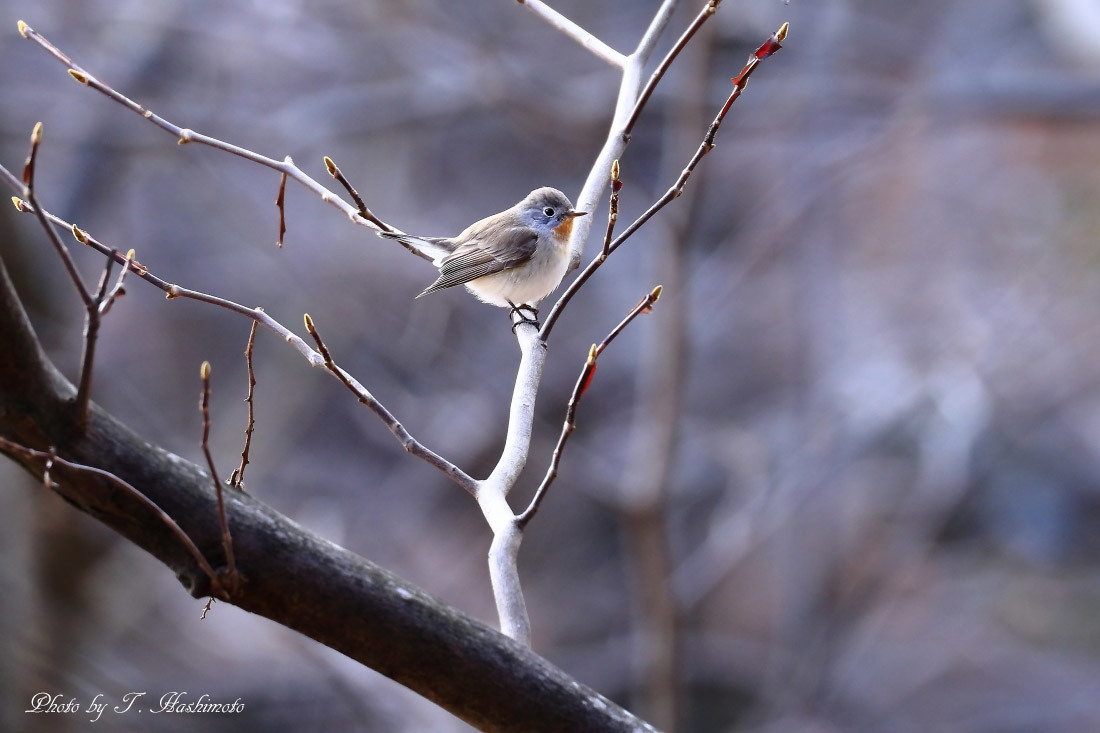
[0,0,1100,732]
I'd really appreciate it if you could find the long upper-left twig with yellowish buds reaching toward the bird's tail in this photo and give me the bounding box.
[19,21,367,226]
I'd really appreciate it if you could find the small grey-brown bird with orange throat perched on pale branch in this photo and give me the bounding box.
[378,188,587,313]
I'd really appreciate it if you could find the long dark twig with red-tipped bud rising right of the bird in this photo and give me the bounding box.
[539,23,788,340]
